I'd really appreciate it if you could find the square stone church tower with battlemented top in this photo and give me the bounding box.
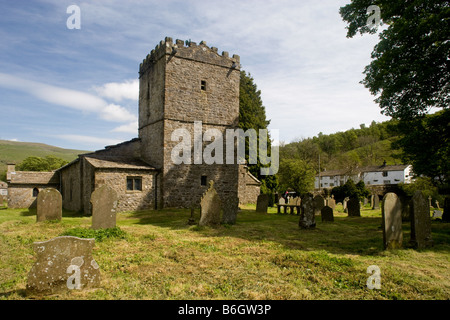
[139,37,240,208]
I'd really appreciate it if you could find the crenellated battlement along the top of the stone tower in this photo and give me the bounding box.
[139,37,240,75]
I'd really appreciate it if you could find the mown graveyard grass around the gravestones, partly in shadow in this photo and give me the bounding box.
[0,205,450,300]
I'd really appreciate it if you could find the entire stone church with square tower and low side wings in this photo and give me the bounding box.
[7,37,260,214]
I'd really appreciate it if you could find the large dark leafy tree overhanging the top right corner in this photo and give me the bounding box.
[340,0,450,119]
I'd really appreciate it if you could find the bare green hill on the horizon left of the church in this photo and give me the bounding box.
[0,140,89,180]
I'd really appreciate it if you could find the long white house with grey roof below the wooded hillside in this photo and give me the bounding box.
[314,163,413,189]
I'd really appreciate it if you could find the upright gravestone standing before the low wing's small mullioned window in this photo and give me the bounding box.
[91,184,117,229]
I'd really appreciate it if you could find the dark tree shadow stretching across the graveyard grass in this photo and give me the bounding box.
[127,209,450,256]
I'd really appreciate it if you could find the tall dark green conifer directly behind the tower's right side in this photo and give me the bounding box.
[239,71,278,193]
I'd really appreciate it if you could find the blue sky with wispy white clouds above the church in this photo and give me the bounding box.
[0,0,389,150]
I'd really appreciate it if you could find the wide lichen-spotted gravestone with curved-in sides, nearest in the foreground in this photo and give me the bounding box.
[26,236,100,295]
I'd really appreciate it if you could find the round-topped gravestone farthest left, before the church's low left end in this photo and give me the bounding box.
[36,188,62,222]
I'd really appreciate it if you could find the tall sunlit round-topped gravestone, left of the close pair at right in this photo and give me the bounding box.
[381,192,403,249]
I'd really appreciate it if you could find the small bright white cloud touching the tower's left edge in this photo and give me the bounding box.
[94,79,139,102]
